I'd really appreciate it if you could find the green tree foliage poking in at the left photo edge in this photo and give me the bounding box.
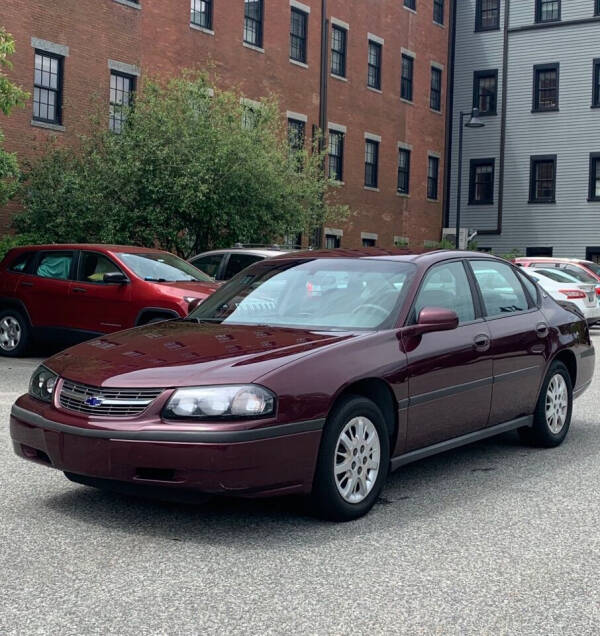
[0,26,29,206]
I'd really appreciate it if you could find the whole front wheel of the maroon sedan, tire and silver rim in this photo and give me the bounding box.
[312,396,390,521]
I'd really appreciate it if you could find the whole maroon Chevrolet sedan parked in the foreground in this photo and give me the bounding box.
[10,249,594,520]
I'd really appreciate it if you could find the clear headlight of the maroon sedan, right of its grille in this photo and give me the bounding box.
[163,384,275,419]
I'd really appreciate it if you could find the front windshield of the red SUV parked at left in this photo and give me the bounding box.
[118,252,213,283]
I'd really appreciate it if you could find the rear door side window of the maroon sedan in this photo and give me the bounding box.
[470,261,529,317]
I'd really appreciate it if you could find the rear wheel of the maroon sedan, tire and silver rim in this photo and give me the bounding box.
[519,361,573,448]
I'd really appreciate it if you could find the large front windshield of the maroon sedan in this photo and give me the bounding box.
[188,258,416,331]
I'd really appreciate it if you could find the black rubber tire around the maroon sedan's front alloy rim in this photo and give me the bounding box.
[312,395,390,521]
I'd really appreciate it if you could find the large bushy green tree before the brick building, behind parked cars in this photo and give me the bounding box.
[16,73,345,257]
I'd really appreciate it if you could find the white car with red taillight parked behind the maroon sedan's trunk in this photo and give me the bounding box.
[524,268,600,325]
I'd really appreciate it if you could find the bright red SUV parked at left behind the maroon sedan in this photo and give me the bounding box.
[0,244,218,356]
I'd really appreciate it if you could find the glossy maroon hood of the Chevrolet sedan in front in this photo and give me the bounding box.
[46,320,358,388]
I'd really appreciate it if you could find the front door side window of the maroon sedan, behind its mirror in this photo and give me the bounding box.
[414,262,475,323]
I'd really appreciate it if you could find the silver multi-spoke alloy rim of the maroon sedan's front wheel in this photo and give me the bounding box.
[333,416,381,504]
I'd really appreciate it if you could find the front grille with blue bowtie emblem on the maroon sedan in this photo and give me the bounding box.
[60,380,162,417]
